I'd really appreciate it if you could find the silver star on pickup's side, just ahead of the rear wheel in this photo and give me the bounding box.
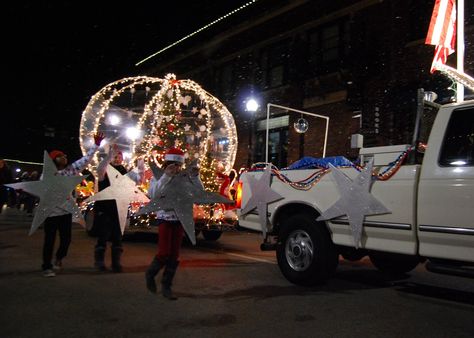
[316,161,391,248]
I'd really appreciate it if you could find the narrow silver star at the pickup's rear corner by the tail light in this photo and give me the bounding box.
[241,164,283,237]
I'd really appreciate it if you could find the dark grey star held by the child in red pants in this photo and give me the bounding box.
[137,168,233,245]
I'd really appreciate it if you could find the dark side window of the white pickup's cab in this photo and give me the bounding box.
[439,108,474,166]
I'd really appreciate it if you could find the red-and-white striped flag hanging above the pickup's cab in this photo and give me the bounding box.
[425,0,456,73]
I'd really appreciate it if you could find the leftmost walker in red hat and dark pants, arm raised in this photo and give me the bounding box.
[41,133,104,277]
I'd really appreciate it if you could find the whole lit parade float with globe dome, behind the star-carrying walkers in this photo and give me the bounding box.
[78,74,241,240]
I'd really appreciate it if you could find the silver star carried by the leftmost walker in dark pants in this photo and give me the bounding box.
[5,151,84,235]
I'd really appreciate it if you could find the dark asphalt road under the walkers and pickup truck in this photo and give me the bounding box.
[0,210,474,338]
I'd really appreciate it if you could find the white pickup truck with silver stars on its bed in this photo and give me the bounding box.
[238,95,474,285]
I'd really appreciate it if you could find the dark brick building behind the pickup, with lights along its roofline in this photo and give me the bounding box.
[143,0,474,168]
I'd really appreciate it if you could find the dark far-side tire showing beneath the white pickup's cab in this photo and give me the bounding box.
[369,251,420,274]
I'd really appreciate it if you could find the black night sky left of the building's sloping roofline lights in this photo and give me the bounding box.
[0,0,252,162]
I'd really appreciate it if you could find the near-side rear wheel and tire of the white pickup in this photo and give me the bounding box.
[276,214,338,286]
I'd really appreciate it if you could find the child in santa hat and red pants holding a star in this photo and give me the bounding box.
[145,148,202,300]
